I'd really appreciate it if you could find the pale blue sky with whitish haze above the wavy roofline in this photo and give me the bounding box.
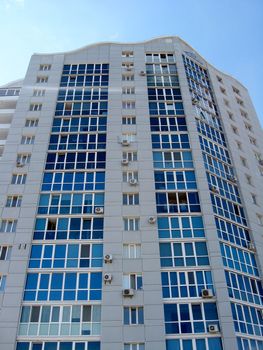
[0,0,263,124]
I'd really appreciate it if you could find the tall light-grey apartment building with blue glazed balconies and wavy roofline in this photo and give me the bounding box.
[0,37,263,350]
